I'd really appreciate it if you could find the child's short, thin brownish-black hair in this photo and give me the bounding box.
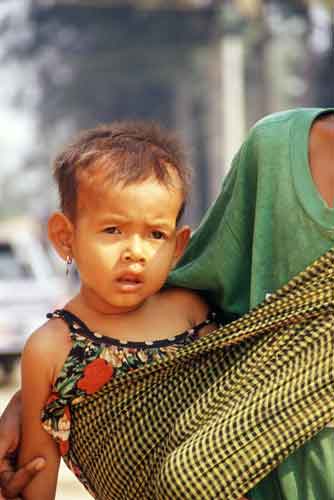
[54,121,190,221]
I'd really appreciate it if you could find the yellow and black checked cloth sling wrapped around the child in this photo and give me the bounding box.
[70,251,334,500]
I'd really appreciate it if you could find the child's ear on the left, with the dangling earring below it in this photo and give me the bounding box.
[48,212,73,260]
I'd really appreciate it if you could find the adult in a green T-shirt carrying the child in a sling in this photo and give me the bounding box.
[0,109,334,500]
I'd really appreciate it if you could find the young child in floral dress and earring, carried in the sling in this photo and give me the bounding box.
[20,123,214,500]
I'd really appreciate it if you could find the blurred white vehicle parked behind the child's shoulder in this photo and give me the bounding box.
[0,219,69,380]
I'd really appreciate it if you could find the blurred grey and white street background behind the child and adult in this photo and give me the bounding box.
[0,0,334,500]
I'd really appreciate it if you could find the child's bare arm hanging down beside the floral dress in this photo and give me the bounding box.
[19,327,60,500]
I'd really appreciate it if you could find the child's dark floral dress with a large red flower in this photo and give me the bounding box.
[41,309,216,496]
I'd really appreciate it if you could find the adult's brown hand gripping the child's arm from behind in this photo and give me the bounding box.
[0,392,45,500]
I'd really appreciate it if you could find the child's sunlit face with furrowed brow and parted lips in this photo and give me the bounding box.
[72,172,189,313]
